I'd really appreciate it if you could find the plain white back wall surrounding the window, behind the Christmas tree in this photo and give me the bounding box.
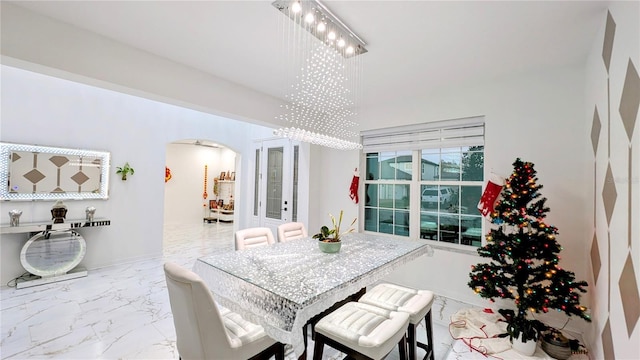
[310,65,591,334]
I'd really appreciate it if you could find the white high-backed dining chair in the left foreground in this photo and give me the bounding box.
[164,262,284,360]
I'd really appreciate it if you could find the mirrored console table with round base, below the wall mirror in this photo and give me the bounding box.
[0,219,111,289]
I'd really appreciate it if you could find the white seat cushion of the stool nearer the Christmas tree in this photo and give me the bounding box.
[358,283,433,324]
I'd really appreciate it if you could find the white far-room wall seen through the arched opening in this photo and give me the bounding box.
[164,144,236,224]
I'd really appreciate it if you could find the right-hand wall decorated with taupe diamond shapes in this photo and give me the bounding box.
[581,1,640,359]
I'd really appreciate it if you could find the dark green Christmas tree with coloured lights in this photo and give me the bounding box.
[468,159,591,341]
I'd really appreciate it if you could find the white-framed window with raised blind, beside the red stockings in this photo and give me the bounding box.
[363,117,484,246]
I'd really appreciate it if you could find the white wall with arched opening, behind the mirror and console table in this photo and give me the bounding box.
[0,65,271,284]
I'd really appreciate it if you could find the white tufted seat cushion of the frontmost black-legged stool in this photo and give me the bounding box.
[315,302,409,359]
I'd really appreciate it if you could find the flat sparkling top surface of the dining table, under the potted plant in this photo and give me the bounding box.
[198,234,428,305]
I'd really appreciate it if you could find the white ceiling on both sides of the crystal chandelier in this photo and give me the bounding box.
[15,0,607,109]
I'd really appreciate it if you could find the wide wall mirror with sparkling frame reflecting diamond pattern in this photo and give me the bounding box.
[0,143,111,201]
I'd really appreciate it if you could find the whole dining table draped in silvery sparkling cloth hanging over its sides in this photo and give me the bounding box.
[193,233,433,358]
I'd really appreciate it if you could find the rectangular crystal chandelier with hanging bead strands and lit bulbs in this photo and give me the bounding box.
[272,0,367,150]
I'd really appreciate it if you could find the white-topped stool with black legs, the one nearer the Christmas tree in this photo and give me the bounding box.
[358,283,434,360]
